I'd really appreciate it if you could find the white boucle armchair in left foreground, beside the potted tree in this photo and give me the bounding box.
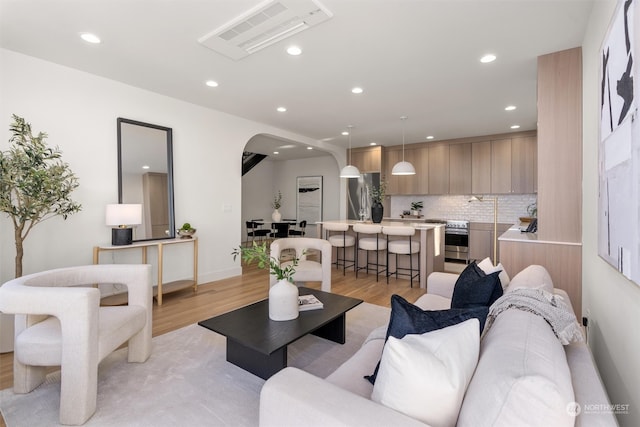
[0,265,153,425]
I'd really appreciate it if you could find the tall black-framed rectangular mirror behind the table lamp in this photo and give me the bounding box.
[118,118,176,241]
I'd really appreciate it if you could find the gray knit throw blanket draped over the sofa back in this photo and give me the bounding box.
[481,289,584,345]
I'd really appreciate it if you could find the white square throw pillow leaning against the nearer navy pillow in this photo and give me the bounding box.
[371,319,480,427]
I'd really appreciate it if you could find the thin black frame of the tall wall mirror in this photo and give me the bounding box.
[117,117,176,242]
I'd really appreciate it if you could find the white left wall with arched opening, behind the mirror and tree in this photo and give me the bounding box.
[0,49,345,283]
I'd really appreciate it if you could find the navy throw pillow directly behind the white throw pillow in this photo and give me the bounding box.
[365,295,489,384]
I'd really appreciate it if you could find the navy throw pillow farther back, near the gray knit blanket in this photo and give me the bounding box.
[451,261,502,308]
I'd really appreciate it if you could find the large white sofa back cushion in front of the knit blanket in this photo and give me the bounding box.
[458,310,575,427]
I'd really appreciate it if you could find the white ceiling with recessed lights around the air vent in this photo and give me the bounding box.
[0,0,592,158]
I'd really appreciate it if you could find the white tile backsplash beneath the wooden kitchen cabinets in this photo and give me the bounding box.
[385,194,537,224]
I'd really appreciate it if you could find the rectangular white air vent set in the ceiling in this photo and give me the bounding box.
[198,0,333,61]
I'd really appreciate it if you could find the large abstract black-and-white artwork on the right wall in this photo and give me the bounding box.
[598,0,640,284]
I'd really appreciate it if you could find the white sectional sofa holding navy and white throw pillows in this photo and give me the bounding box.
[260,266,617,427]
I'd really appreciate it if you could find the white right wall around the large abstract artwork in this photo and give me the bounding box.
[582,0,640,427]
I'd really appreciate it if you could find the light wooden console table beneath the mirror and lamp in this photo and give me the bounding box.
[93,237,198,305]
